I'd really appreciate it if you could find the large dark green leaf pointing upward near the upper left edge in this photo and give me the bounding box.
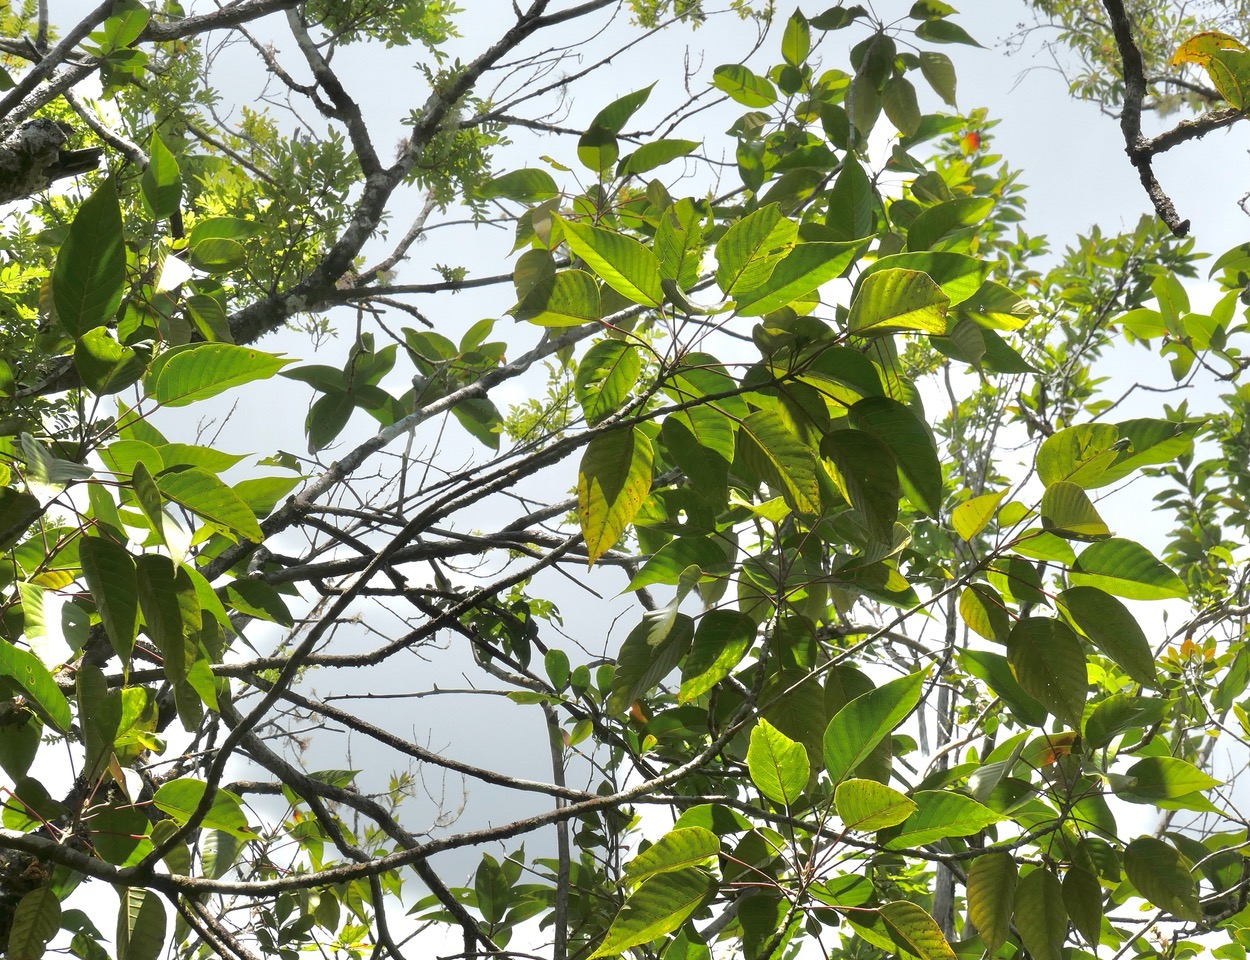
[53,178,126,338]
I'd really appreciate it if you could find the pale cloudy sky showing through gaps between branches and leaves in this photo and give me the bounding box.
[26,0,1250,950]
